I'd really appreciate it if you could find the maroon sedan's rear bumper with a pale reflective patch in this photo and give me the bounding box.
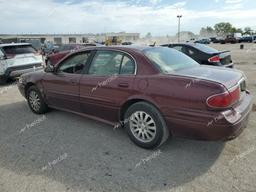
[165,94,252,141]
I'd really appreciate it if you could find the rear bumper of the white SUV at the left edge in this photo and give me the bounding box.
[5,63,43,77]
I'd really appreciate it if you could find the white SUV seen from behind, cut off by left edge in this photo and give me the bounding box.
[0,43,43,84]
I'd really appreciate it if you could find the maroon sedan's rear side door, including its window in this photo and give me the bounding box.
[80,50,136,122]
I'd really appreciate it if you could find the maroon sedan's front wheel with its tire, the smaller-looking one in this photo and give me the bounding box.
[26,86,48,114]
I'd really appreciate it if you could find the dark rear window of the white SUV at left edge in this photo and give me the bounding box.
[3,45,36,55]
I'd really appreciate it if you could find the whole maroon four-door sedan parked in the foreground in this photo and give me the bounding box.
[18,47,252,149]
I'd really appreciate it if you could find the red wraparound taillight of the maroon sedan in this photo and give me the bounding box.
[207,86,240,108]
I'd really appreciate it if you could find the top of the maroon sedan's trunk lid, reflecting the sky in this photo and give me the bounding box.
[176,65,245,89]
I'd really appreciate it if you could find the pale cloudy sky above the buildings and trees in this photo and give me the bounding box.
[0,0,256,35]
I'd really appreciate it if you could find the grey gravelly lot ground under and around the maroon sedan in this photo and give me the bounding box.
[0,44,256,192]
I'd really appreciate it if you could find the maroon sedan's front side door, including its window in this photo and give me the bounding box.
[43,51,91,112]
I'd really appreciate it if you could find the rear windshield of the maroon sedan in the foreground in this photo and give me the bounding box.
[143,47,199,73]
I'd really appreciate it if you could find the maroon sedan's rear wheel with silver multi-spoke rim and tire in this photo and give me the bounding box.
[124,102,169,149]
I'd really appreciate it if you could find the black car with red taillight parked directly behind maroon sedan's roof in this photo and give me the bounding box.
[162,43,233,68]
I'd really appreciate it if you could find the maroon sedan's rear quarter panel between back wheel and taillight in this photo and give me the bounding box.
[128,74,226,136]
